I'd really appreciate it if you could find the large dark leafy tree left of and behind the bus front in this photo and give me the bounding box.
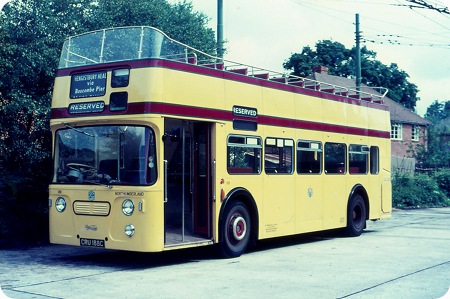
[0,0,215,246]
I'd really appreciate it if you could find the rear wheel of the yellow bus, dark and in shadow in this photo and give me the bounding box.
[346,194,366,237]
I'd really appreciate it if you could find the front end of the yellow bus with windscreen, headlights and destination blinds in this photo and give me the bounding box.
[49,27,171,252]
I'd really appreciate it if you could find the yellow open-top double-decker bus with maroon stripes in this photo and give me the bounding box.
[49,27,391,257]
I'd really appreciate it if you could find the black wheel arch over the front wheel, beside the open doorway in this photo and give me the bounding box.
[218,187,259,245]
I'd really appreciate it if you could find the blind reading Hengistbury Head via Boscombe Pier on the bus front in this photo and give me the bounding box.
[70,71,106,99]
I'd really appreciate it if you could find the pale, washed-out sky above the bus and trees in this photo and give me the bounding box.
[0,0,450,116]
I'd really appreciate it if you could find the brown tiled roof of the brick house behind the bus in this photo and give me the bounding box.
[308,73,431,126]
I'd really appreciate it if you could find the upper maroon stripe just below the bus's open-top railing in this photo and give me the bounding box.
[56,59,389,111]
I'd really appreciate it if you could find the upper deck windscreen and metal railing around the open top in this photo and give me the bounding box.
[59,26,387,103]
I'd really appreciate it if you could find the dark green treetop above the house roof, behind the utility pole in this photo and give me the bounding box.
[283,40,419,110]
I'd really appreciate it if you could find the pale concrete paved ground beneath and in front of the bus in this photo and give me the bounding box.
[0,208,450,299]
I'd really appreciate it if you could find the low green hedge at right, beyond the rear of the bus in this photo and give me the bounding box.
[392,170,450,209]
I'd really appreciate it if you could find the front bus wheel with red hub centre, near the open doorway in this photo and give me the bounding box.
[219,201,252,258]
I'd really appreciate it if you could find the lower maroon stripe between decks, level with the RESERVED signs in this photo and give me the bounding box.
[51,102,390,138]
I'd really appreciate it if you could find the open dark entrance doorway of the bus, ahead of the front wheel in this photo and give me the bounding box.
[163,118,211,247]
